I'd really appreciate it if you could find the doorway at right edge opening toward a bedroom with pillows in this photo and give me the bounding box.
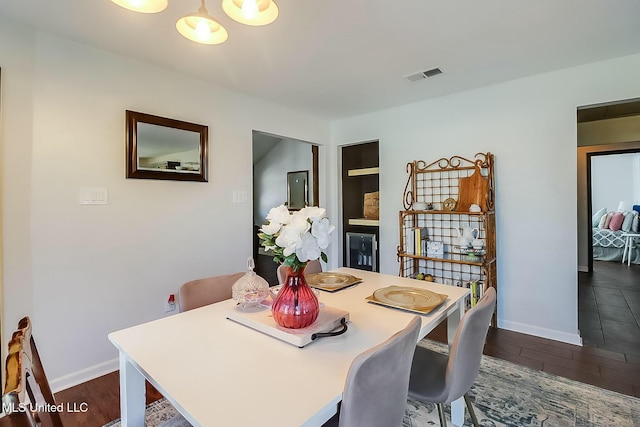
[578,100,640,360]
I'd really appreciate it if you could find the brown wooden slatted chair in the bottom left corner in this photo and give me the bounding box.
[2,317,62,427]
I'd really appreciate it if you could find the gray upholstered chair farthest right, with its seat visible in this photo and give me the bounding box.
[409,287,496,427]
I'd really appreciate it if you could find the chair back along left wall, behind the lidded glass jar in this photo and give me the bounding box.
[178,273,245,312]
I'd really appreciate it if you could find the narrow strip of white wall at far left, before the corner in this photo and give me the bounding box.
[0,20,35,368]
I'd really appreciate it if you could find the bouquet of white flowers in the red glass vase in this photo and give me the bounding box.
[258,205,335,271]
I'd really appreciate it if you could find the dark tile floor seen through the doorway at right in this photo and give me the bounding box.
[578,261,640,360]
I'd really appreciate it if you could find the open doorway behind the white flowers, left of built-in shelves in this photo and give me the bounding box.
[252,131,319,286]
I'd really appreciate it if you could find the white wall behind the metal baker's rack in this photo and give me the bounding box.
[332,51,640,343]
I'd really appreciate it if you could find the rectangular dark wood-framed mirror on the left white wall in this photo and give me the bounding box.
[125,110,209,182]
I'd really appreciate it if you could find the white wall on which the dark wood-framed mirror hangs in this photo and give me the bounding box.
[0,22,329,388]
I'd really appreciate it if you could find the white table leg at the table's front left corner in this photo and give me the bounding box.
[120,352,145,427]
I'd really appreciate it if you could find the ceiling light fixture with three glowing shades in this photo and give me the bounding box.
[111,0,278,44]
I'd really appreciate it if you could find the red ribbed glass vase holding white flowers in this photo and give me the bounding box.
[271,265,320,329]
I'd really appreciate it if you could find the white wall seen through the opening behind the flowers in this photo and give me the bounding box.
[253,139,313,225]
